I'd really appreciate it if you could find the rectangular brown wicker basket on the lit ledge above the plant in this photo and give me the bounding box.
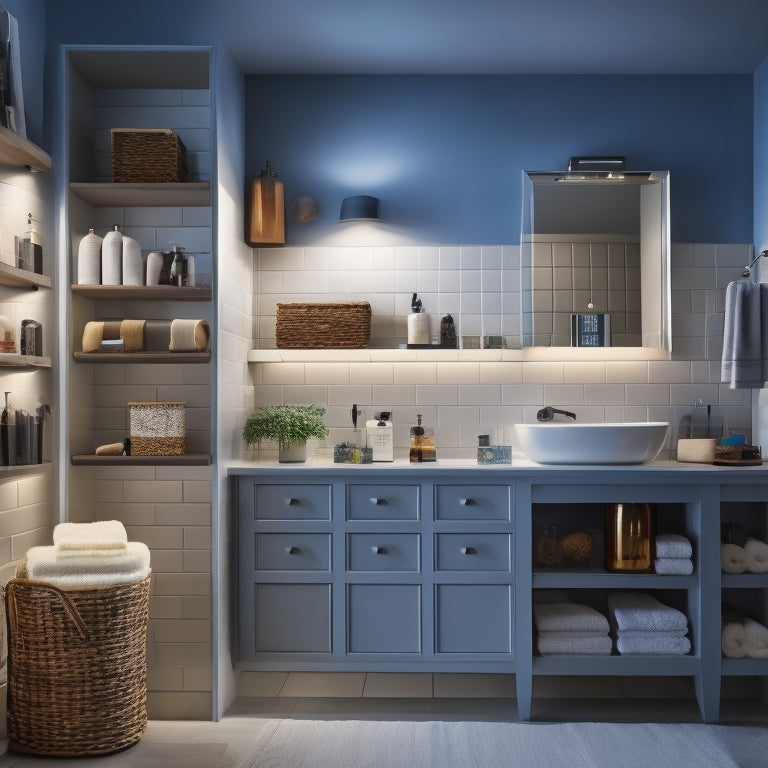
[275,301,371,349]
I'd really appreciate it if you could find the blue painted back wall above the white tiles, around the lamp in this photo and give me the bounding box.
[246,75,753,244]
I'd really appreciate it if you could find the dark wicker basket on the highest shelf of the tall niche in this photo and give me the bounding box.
[112,128,189,184]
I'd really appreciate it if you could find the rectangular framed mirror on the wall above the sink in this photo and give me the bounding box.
[521,172,671,351]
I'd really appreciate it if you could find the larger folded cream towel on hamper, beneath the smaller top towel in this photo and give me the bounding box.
[26,541,150,581]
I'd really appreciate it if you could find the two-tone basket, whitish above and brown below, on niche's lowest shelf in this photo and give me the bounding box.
[128,401,186,456]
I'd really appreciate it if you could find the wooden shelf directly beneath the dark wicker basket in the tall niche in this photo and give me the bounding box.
[69,181,211,207]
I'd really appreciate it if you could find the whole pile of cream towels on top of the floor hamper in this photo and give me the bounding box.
[23,520,150,588]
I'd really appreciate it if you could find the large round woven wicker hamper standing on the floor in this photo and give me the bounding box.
[5,576,151,757]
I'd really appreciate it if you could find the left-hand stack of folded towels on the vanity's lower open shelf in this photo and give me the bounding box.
[533,590,613,655]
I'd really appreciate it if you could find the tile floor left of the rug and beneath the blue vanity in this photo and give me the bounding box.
[0,673,768,768]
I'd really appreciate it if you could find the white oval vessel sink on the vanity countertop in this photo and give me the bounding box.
[515,421,669,464]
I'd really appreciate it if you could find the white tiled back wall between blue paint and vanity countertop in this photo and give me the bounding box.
[251,243,751,458]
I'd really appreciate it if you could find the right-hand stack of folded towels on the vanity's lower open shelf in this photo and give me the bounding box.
[608,591,691,655]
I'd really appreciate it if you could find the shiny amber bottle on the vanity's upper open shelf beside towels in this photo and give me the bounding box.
[605,503,655,571]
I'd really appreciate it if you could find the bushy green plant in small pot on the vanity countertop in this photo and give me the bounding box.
[243,405,328,463]
